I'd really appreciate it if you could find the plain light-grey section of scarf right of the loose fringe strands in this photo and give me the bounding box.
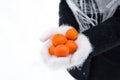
[96,0,119,22]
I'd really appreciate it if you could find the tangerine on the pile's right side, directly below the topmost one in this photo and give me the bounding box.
[65,40,77,54]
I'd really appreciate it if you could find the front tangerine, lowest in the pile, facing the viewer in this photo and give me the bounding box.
[54,45,69,57]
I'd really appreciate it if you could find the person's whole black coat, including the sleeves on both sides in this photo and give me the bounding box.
[59,0,120,80]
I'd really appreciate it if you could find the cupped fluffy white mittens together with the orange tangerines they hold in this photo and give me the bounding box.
[40,26,92,68]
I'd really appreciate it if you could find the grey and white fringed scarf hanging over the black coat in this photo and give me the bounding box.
[66,0,120,32]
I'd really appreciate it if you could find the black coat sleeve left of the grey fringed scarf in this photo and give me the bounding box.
[59,0,79,31]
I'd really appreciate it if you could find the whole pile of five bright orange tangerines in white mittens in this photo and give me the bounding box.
[48,28,78,57]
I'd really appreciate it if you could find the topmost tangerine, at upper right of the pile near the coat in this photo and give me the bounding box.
[65,28,78,40]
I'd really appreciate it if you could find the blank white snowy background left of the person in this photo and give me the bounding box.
[0,0,73,80]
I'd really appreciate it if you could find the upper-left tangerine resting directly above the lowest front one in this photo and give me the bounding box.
[52,34,67,46]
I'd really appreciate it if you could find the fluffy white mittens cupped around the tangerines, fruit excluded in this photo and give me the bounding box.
[40,25,92,69]
